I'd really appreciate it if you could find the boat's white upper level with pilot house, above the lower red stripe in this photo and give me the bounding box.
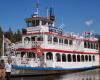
[13,13,98,53]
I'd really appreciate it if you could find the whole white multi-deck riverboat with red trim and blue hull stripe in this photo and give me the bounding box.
[1,5,100,76]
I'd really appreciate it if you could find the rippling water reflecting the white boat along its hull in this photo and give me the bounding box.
[11,69,100,80]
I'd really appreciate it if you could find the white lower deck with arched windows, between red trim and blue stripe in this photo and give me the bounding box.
[6,52,100,68]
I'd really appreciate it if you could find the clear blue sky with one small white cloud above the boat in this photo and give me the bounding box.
[0,0,100,34]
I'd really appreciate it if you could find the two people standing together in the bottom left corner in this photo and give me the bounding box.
[0,59,12,80]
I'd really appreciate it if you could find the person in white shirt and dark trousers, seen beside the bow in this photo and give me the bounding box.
[5,59,12,80]
